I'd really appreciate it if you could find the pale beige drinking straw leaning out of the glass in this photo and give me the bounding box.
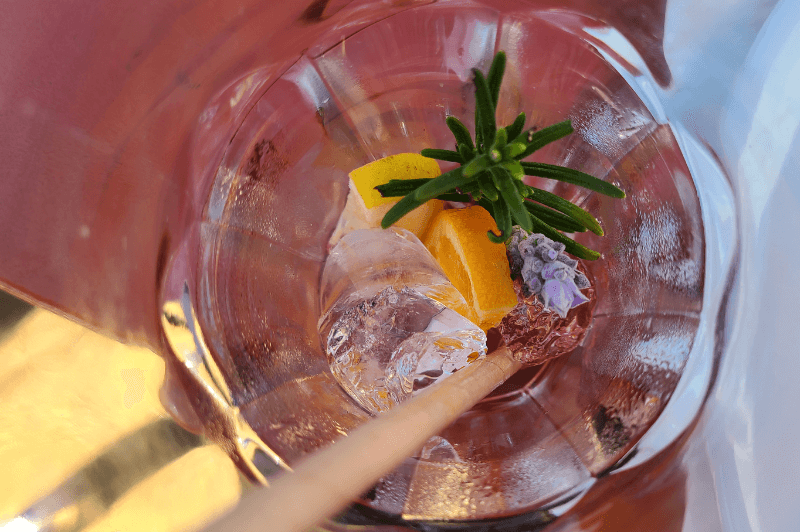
[205,347,521,532]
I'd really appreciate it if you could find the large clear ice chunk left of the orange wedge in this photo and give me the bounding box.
[320,229,486,414]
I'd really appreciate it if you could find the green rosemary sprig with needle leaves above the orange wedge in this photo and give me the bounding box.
[375,52,625,260]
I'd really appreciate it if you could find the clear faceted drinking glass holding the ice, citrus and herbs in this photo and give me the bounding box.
[156,1,735,527]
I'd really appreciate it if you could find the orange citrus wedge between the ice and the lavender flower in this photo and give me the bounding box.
[423,206,517,331]
